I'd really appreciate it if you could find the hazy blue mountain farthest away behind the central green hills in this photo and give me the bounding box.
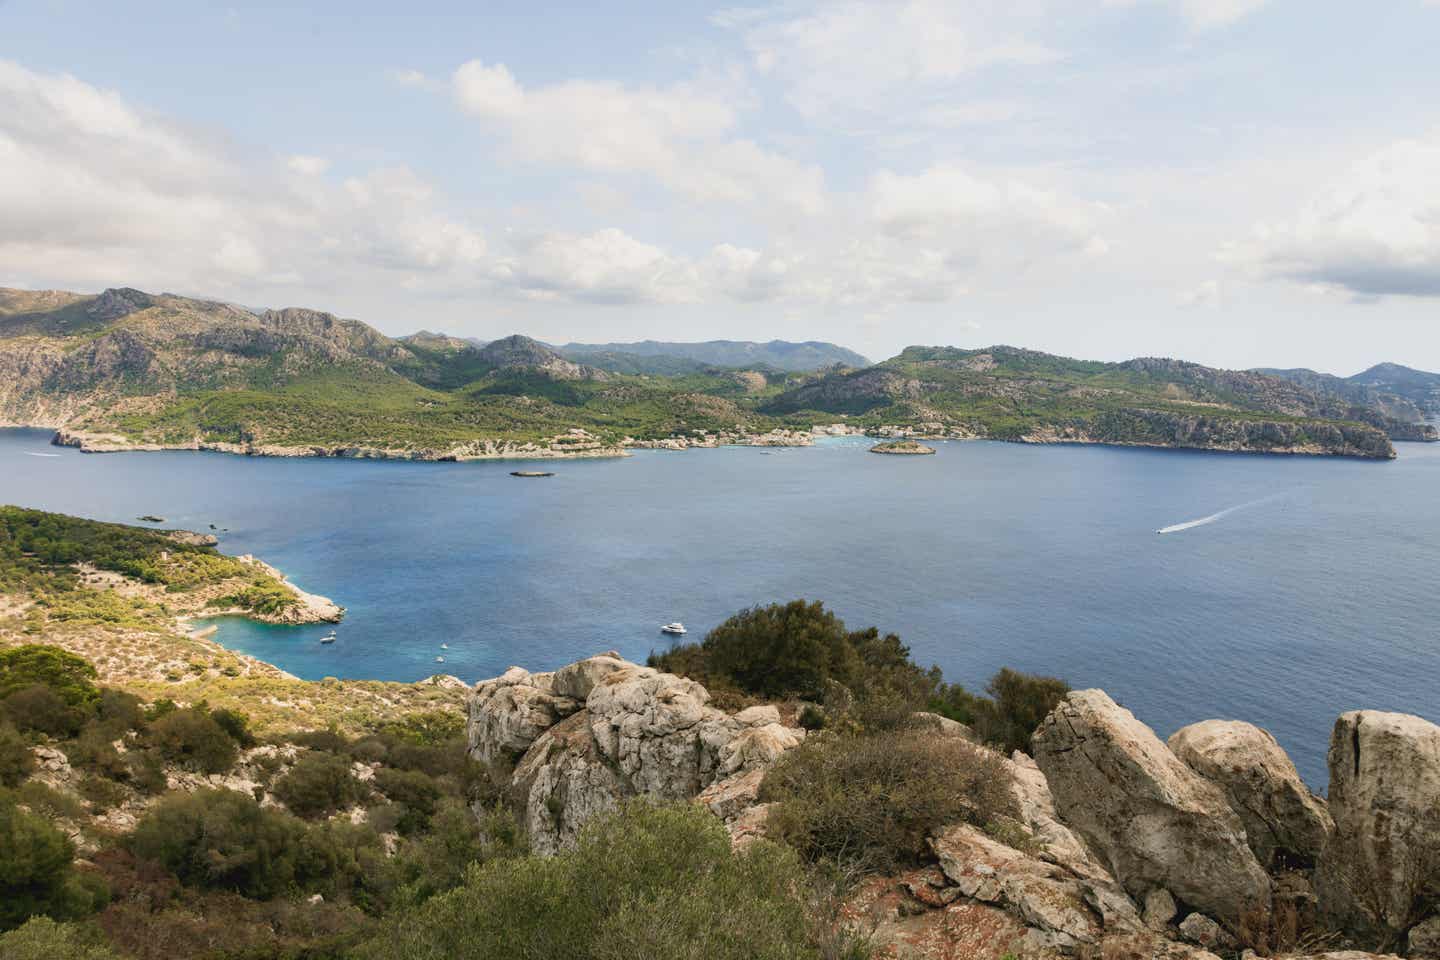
[556,340,870,373]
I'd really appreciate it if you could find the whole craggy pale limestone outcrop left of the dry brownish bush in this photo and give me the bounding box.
[468,652,805,853]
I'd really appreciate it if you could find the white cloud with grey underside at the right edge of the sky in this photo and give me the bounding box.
[1223,132,1440,298]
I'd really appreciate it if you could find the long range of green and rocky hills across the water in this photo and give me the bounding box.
[0,288,1440,459]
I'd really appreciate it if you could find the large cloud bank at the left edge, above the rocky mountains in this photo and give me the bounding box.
[0,60,484,292]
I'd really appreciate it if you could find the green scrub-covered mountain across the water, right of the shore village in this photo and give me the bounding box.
[760,347,1416,456]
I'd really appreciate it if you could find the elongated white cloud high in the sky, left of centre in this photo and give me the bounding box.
[452,60,825,214]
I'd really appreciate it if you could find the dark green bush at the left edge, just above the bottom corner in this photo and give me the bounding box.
[0,796,105,932]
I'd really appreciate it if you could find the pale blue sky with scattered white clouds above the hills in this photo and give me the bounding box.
[0,0,1440,374]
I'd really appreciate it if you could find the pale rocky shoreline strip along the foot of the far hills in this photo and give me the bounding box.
[25,423,1397,463]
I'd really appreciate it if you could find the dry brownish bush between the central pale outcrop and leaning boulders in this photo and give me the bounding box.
[760,730,1015,869]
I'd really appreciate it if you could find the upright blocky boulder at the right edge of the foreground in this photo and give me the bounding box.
[1315,710,1440,940]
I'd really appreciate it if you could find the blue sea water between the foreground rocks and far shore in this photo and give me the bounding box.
[0,430,1440,787]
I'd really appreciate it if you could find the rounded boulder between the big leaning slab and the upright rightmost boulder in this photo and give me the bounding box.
[1169,720,1335,868]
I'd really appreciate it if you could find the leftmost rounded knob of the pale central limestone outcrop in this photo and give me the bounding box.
[467,666,580,763]
